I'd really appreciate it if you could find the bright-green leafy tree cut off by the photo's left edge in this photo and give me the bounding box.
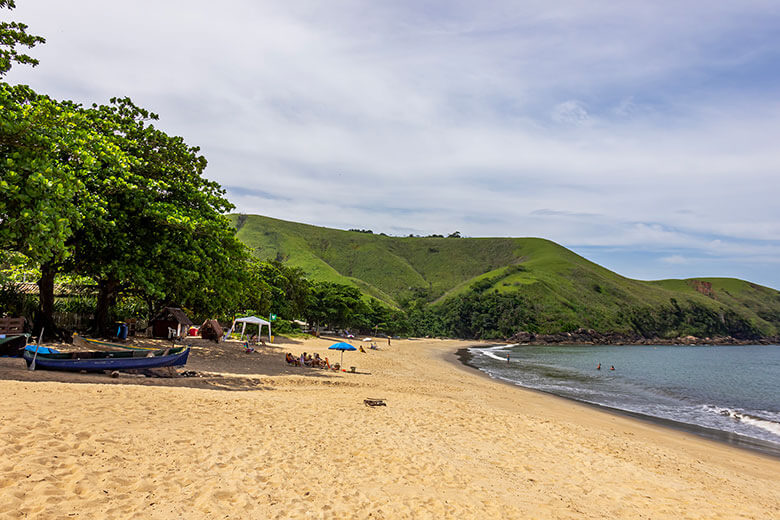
[0,83,129,333]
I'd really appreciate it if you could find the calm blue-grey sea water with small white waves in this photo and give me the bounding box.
[469,345,780,451]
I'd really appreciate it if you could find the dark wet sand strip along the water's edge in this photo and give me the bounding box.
[449,345,780,460]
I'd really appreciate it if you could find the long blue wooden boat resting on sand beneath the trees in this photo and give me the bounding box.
[23,347,190,372]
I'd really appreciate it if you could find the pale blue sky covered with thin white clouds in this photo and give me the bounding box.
[6,0,780,288]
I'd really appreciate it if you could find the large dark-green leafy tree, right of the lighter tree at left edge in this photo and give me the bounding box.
[73,98,246,332]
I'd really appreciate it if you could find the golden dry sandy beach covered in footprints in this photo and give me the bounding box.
[0,339,780,519]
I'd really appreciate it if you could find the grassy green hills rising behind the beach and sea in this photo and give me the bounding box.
[231,215,780,337]
